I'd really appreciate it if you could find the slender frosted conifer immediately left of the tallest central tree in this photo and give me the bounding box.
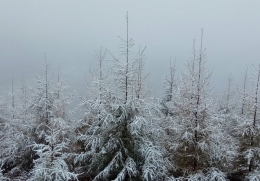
[75,48,116,176]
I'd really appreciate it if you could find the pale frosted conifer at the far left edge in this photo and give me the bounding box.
[0,78,33,179]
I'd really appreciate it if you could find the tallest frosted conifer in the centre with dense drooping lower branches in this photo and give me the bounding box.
[75,13,170,181]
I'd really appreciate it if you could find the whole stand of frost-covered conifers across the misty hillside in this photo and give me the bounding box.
[0,16,260,181]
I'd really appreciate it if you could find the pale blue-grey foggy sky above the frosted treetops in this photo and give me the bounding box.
[0,0,260,97]
